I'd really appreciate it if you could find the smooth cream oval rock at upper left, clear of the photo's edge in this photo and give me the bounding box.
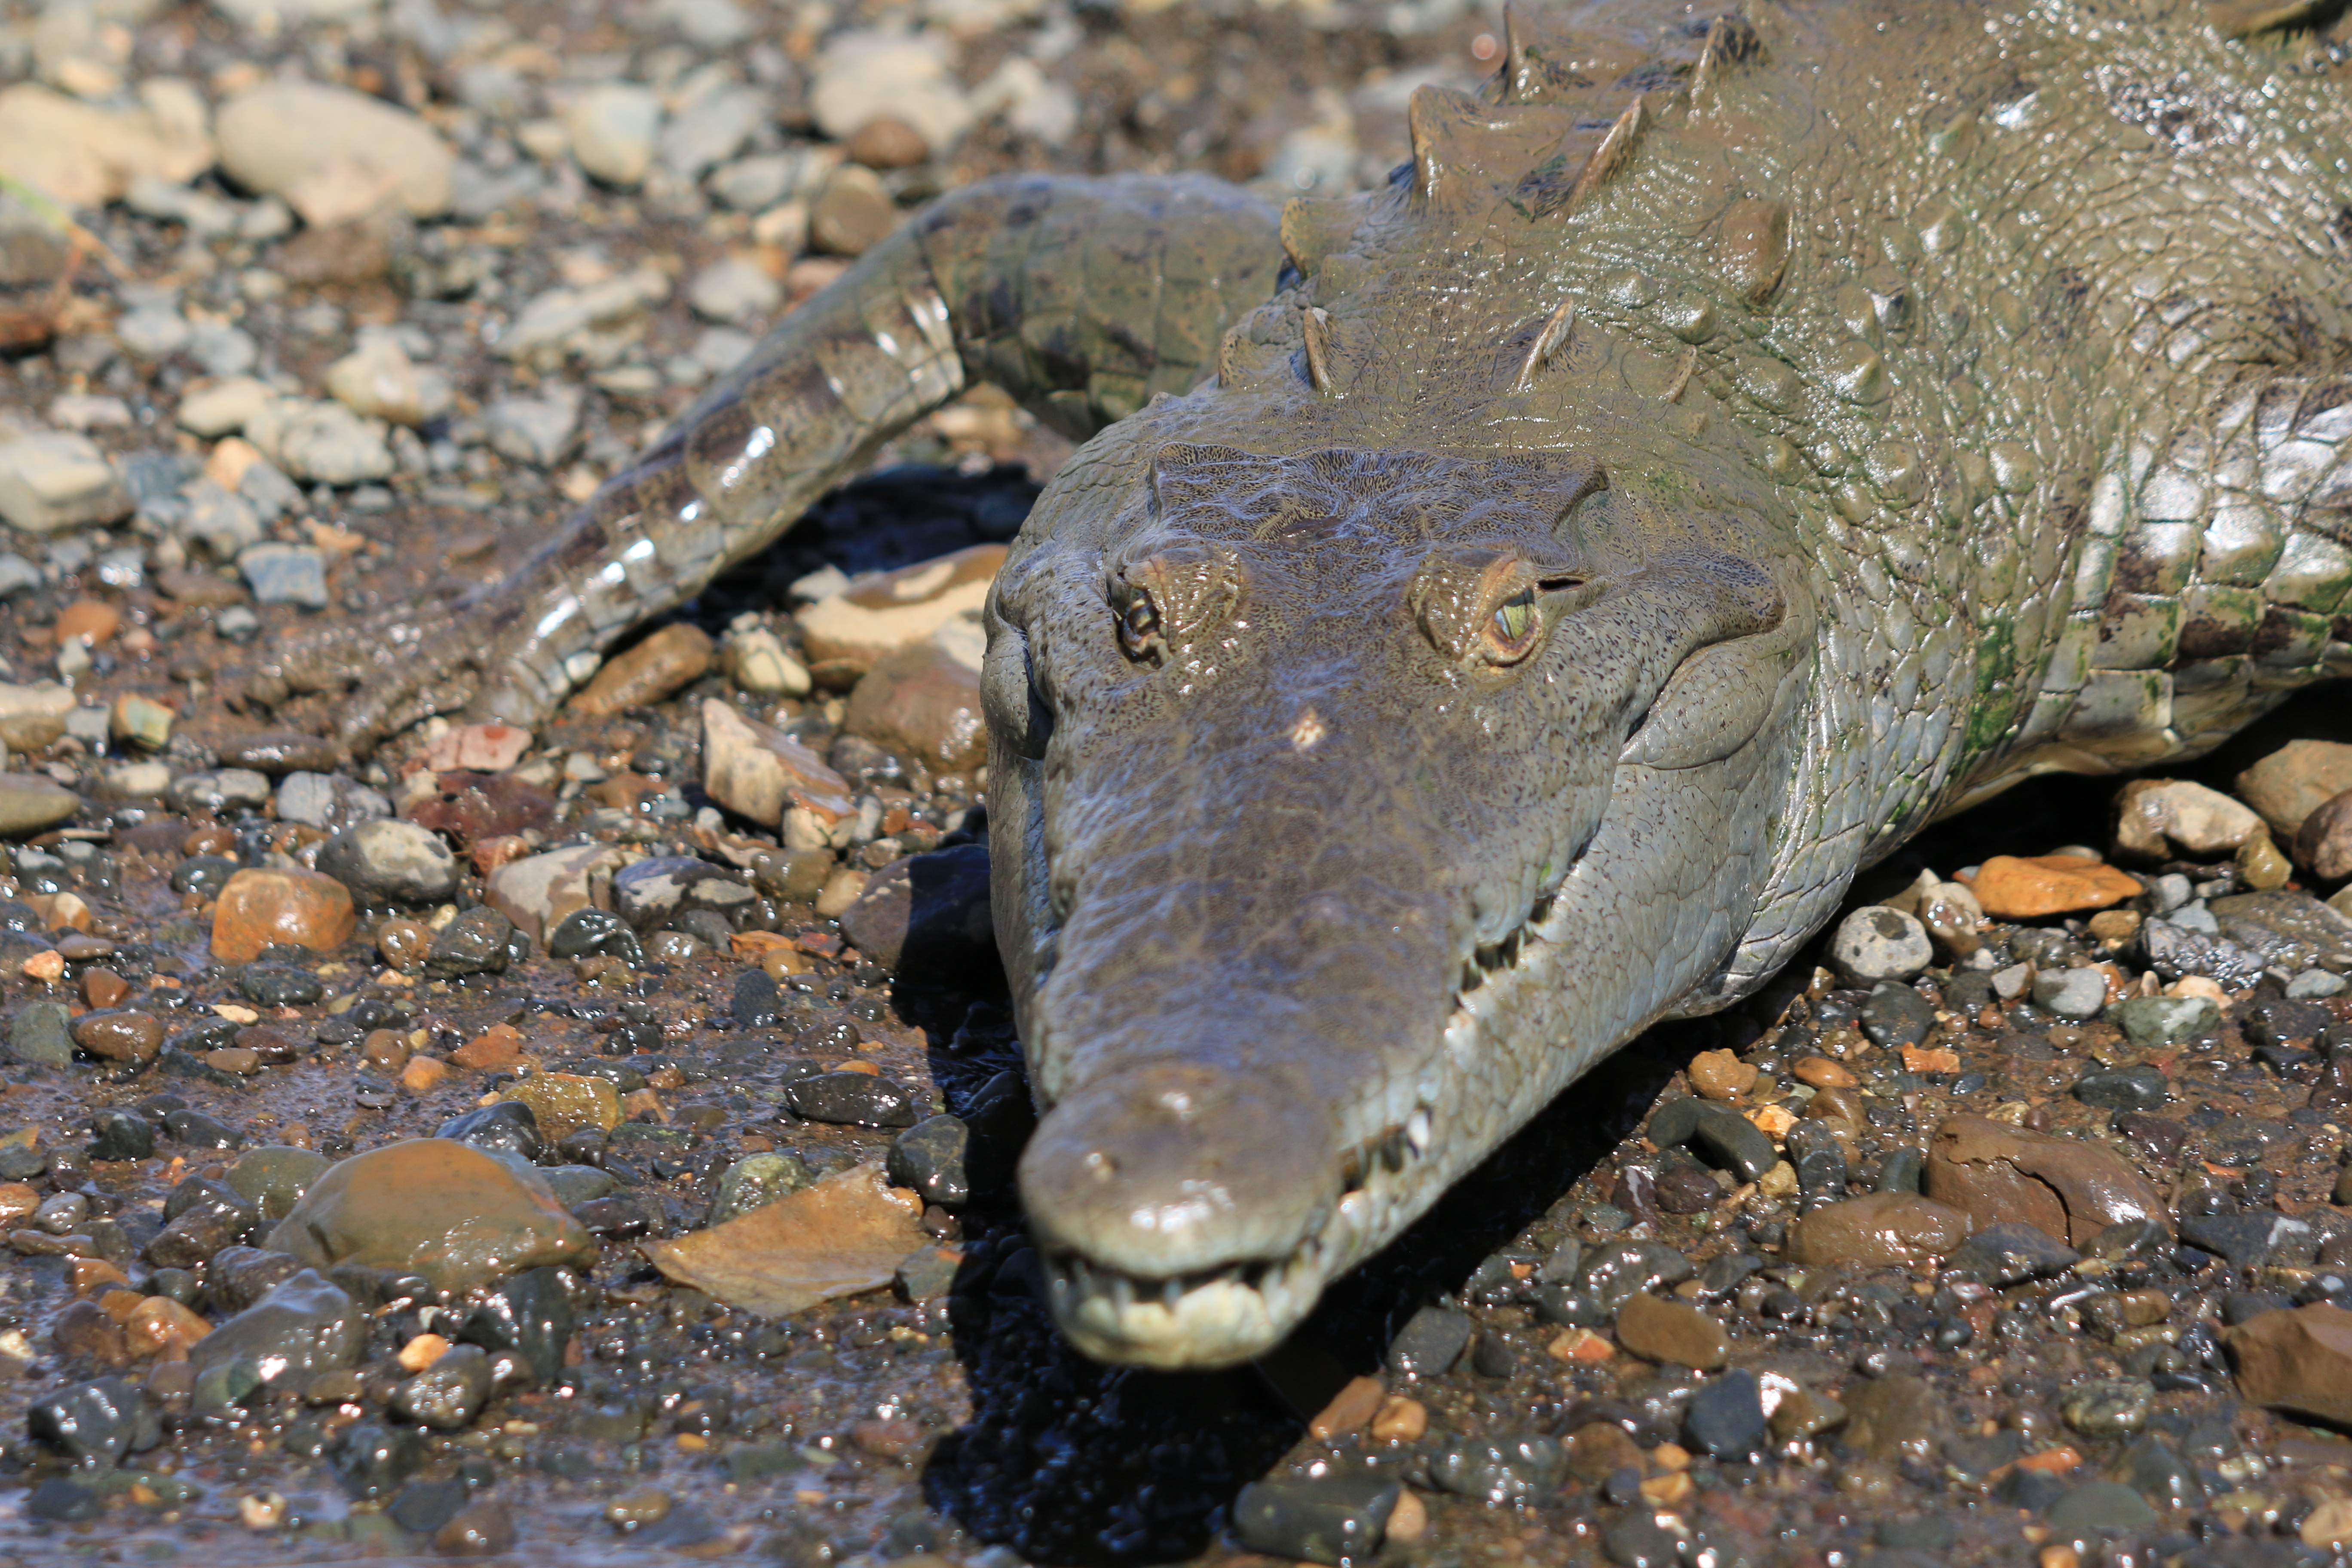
[214,82,456,226]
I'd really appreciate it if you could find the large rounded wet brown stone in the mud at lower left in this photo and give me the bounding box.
[268,1133,595,1291]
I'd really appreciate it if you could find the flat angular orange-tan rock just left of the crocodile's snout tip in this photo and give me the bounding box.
[644,1164,931,1317]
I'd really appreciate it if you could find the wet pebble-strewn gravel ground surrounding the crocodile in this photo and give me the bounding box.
[18,0,2352,1568]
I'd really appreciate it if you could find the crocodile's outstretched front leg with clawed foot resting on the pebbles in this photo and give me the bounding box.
[278,176,1282,755]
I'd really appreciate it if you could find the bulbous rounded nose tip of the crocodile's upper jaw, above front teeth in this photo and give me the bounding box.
[1021,1060,1341,1279]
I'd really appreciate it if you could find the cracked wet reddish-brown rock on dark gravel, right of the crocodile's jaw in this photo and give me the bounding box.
[1922,1117,2168,1246]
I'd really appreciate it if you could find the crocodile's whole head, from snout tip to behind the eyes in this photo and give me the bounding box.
[983,444,1811,1366]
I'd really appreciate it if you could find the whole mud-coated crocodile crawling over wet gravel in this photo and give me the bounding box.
[298,0,2352,1368]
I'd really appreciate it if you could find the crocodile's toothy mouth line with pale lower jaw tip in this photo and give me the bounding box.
[1040,893,1557,1371]
